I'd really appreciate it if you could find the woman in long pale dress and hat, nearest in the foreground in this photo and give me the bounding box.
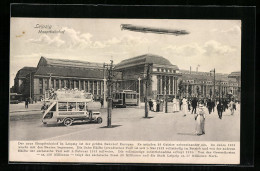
[195,104,205,135]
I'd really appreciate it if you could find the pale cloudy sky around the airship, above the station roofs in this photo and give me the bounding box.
[10,18,241,87]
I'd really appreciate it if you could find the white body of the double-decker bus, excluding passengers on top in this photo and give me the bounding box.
[42,99,102,126]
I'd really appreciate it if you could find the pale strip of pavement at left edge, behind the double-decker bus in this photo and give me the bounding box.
[9,102,43,113]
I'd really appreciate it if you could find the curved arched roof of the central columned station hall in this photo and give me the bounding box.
[115,54,179,70]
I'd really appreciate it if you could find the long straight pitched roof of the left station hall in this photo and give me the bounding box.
[37,57,103,68]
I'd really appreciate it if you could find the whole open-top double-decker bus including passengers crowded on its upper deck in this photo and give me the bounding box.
[42,89,102,126]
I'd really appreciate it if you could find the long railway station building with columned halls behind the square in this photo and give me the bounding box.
[11,54,241,101]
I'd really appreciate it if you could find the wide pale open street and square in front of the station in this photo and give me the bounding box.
[9,104,240,141]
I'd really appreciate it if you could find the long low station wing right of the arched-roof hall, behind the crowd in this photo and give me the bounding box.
[179,70,240,100]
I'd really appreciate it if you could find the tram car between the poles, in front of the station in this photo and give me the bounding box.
[112,90,138,107]
